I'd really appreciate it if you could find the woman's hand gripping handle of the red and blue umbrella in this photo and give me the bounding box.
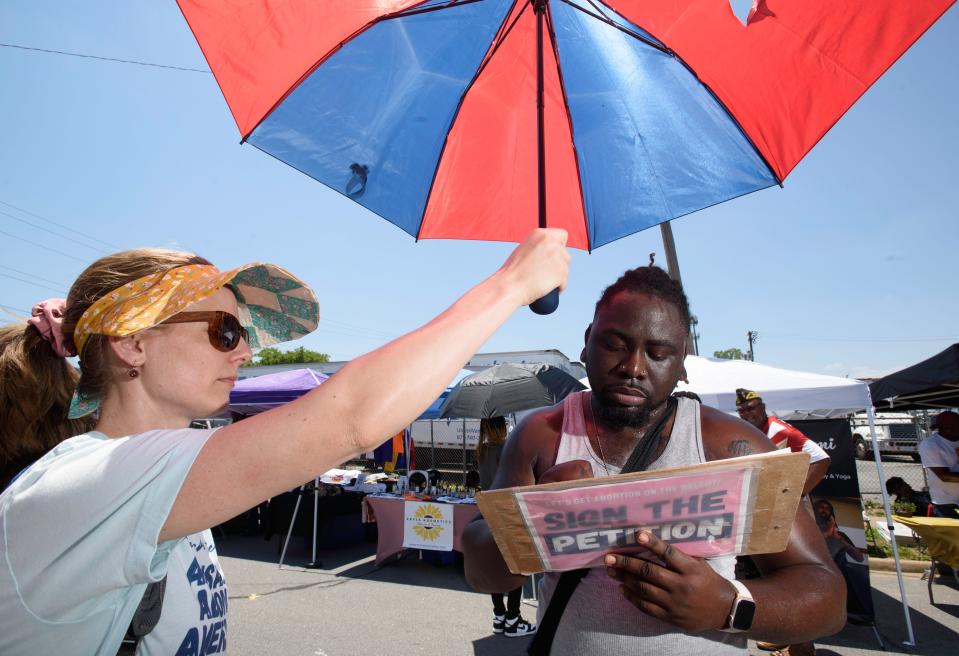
[500,228,569,305]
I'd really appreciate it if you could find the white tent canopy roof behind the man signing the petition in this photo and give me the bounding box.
[582,355,871,419]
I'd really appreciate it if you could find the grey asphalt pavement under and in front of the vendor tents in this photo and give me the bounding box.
[217,536,959,656]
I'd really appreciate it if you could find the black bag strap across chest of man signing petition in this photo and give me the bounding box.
[526,396,678,656]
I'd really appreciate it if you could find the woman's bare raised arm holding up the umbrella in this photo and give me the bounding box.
[160,229,569,540]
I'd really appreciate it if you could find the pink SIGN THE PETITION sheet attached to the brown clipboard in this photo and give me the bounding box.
[516,468,755,571]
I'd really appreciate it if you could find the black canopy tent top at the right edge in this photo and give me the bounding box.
[869,343,959,410]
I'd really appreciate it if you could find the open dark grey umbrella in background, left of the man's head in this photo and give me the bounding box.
[440,363,586,418]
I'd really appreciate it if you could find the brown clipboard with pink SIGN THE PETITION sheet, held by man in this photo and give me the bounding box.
[476,451,809,574]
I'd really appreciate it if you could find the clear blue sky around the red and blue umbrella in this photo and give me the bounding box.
[0,0,959,376]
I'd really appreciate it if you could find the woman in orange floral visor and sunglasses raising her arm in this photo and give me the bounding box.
[0,229,568,655]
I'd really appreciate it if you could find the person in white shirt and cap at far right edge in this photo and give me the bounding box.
[919,410,959,519]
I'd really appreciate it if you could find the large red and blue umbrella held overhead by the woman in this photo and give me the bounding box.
[178,0,954,254]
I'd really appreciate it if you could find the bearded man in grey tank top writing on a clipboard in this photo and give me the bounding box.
[463,267,845,656]
